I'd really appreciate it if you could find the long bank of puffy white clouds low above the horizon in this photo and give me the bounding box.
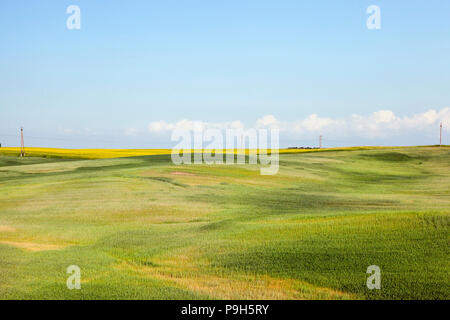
[146,108,450,141]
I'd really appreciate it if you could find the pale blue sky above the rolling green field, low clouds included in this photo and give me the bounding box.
[0,0,450,148]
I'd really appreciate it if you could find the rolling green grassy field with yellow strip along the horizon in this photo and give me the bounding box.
[0,147,450,299]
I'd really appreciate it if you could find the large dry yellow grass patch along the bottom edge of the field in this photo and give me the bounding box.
[116,247,357,300]
